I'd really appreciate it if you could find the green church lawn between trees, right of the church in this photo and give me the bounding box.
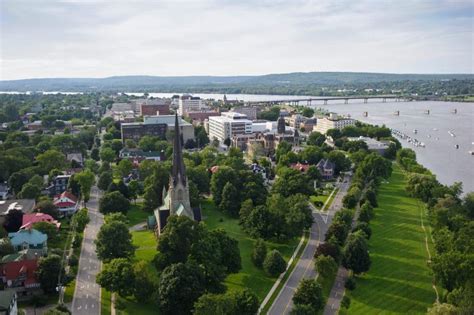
[201,200,299,301]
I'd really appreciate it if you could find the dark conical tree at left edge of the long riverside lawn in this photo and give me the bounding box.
[342,231,371,274]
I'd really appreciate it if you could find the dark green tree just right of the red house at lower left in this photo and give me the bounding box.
[36,254,64,293]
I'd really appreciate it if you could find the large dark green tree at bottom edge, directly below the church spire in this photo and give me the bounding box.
[159,263,205,315]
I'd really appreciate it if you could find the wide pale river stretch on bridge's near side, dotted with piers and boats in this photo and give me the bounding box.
[320,100,474,192]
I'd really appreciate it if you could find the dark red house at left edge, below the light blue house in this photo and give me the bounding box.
[0,249,43,296]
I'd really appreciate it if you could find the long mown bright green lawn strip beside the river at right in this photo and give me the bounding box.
[348,165,436,314]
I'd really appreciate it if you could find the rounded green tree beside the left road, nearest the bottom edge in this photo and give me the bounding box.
[96,258,135,297]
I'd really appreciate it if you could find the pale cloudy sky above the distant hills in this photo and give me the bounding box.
[0,0,474,80]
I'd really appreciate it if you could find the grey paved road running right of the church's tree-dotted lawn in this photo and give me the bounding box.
[268,178,350,315]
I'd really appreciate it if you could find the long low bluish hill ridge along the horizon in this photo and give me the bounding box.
[0,72,474,93]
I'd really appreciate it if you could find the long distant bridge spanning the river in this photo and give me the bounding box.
[245,95,415,106]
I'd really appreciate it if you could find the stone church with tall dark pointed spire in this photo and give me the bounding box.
[154,114,201,237]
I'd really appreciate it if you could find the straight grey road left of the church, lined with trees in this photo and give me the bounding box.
[71,187,104,315]
